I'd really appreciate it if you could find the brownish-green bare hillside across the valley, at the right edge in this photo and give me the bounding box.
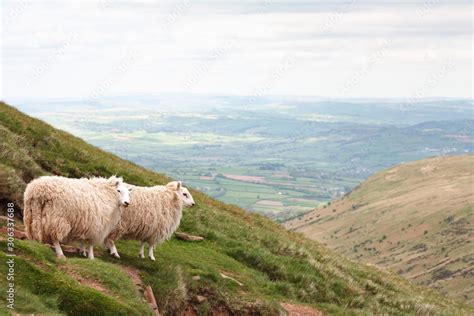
[285,155,474,306]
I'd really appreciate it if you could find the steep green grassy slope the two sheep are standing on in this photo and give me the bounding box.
[0,103,473,315]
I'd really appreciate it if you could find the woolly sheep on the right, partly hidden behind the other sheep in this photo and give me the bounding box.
[105,181,195,261]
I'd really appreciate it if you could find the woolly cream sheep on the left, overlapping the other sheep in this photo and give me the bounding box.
[24,176,130,259]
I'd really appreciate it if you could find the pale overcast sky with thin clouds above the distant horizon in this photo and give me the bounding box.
[0,0,473,101]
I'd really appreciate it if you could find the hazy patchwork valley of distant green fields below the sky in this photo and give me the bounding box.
[16,95,473,221]
